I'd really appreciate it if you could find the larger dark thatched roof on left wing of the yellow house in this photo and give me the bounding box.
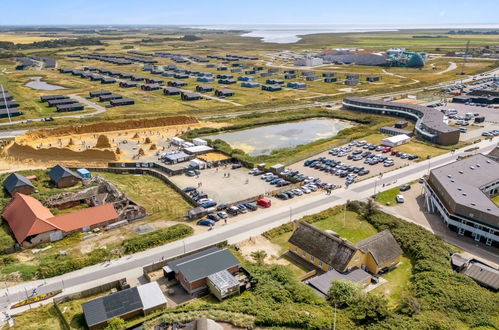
[289,222,357,272]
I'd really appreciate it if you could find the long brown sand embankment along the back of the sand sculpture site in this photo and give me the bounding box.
[19,116,198,141]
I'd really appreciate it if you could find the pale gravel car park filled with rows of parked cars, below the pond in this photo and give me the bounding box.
[289,139,413,186]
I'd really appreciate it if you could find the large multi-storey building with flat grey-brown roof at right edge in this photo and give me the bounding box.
[424,154,499,246]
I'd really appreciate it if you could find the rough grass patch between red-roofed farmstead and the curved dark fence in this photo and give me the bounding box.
[98,172,190,220]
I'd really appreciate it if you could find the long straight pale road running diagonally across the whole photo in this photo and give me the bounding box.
[0,141,497,314]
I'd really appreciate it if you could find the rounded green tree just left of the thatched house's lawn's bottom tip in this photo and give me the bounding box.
[349,293,389,324]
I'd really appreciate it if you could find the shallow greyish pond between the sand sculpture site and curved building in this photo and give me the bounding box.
[206,119,354,156]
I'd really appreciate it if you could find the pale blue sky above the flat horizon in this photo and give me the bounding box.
[0,0,499,25]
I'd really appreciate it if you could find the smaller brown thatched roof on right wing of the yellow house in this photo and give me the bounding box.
[355,230,403,265]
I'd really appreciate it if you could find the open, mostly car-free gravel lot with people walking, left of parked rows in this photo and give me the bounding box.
[170,166,276,204]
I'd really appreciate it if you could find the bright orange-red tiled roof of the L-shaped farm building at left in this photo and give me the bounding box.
[2,193,118,243]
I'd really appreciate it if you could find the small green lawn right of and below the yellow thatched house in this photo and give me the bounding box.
[373,256,412,308]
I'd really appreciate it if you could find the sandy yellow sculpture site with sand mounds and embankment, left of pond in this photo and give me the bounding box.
[0,116,224,170]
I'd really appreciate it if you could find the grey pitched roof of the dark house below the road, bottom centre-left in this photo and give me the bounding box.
[168,247,240,282]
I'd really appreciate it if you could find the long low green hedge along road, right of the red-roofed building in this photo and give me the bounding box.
[123,224,194,254]
